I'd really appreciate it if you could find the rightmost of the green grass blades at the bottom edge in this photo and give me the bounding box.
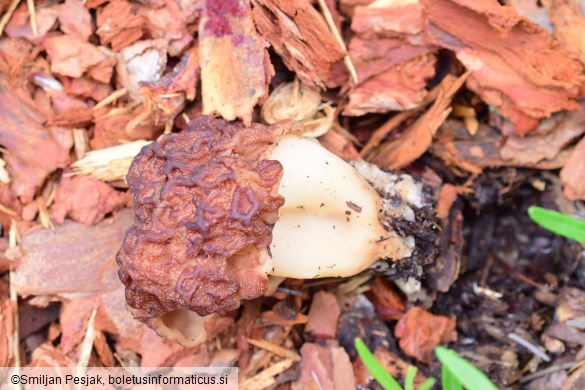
[435,347,497,390]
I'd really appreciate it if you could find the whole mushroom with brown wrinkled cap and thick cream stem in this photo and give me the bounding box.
[116,116,435,345]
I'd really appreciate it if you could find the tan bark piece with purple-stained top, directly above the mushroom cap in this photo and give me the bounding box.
[199,0,274,126]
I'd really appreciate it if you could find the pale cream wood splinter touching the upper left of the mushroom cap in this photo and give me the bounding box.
[68,140,151,181]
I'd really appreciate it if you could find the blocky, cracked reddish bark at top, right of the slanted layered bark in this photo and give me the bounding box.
[344,1,436,116]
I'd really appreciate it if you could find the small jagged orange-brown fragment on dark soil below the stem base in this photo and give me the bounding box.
[394,306,457,363]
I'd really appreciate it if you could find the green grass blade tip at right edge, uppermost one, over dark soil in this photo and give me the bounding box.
[528,206,585,243]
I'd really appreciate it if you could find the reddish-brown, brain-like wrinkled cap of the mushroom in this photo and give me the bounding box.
[116,116,288,326]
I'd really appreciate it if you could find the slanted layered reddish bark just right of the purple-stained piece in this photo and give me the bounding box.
[252,0,347,89]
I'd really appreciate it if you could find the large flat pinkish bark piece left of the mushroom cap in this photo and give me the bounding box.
[8,210,133,299]
